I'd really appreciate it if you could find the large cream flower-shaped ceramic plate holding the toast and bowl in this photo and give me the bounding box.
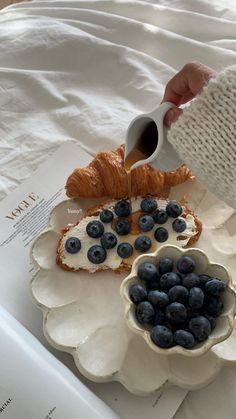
[31,182,236,395]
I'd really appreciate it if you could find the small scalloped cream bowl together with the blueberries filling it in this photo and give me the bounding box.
[120,245,236,356]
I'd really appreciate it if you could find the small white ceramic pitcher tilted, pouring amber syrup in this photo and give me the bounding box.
[124,102,183,172]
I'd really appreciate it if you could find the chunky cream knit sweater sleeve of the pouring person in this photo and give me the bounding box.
[168,66,236,208]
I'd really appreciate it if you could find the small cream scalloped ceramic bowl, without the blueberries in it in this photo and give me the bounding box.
[120,245,236,357]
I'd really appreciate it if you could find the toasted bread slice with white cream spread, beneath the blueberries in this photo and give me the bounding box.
[56,197,202,273]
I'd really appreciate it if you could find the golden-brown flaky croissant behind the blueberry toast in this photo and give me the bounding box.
[66,144,194,198]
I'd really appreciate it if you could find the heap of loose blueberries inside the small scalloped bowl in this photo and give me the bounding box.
[129,255,226,349]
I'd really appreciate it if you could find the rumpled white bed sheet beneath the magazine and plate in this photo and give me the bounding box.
[0,0,236,419]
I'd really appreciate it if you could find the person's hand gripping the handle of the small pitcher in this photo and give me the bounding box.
[162,62,216,126]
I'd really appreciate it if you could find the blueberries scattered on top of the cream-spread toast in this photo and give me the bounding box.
[65,198,187,264]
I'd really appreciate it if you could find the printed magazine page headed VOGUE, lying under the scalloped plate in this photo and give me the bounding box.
[0,142,187,419]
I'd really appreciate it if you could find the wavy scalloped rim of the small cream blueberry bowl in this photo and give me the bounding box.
[120,244,236,357]
